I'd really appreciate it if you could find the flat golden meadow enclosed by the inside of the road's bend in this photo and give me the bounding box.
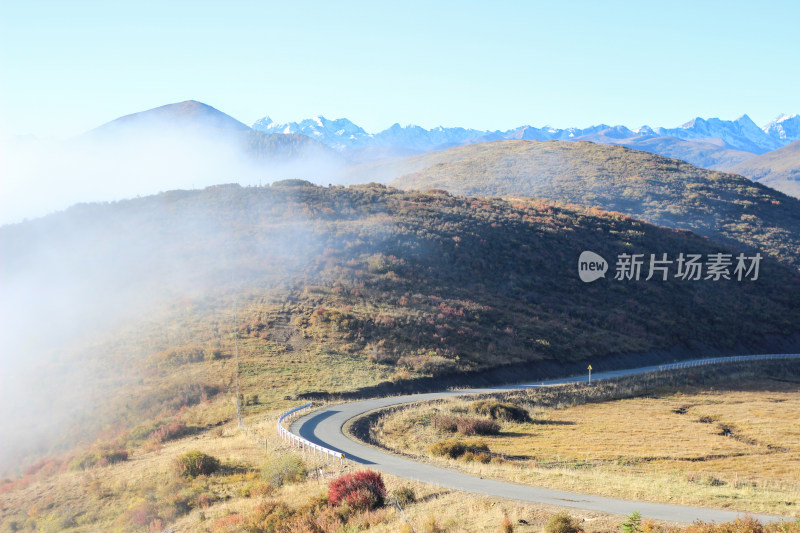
[371,364,800,516]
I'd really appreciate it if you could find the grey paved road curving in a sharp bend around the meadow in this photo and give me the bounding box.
[289,354,800,522]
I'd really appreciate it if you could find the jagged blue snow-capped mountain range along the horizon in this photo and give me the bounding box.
[253,115,800,159]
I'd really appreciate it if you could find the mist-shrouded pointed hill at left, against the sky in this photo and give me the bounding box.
[0,101,345,224]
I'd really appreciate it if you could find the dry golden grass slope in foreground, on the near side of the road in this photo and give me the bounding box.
[0,417,644,533]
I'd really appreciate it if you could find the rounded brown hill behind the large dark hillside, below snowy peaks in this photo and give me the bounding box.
[378,141,800,268]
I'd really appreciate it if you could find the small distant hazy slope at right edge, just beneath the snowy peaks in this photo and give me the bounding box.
[729,141,800,198]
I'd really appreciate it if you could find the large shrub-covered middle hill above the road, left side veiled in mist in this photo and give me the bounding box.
[0,182,800,470]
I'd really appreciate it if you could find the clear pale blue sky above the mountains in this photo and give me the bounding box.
[0,0,800,138]
